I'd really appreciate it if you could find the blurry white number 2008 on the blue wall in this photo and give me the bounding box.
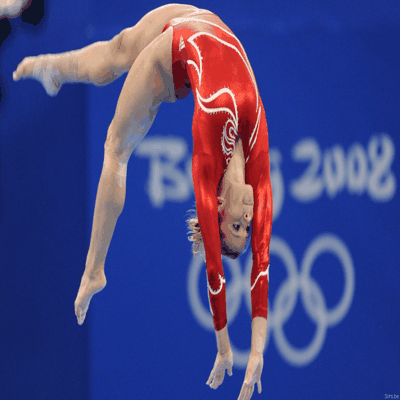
[290,134,396,202]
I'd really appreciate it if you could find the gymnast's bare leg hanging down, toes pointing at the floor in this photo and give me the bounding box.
[75,28,174,324]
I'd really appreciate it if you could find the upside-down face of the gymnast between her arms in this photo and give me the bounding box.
[220,182,254,258]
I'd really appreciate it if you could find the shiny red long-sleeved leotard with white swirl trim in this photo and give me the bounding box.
[163,12,272,331]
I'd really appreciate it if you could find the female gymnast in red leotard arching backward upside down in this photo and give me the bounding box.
[13,4,272,400]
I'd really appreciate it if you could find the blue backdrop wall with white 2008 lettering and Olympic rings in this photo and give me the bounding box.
[0,0,400,400]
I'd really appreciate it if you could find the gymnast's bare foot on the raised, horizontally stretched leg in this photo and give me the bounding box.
[13,54,63,96]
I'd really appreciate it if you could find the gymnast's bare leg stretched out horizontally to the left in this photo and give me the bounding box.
[13,4,195,96]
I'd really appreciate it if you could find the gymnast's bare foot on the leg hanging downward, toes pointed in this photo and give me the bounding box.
[75,269,107,325]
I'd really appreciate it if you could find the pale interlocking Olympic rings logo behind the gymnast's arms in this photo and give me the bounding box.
[187,233,355,368]
